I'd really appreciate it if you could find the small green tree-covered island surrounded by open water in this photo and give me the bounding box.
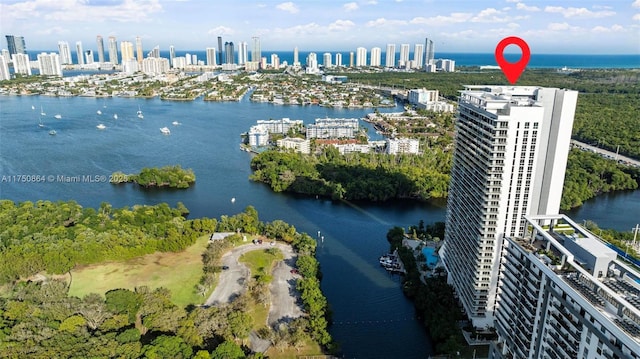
[109,165,196,188]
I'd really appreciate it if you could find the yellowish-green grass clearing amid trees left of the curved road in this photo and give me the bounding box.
[69,236,209,307]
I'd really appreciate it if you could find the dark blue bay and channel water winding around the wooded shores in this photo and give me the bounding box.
[0,96,640,358]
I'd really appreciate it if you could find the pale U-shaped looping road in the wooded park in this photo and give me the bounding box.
[204,242,303,326]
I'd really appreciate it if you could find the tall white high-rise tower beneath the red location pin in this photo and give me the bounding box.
[441,86,578,327]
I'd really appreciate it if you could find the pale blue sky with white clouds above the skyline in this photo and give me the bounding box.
[0,0,640,54]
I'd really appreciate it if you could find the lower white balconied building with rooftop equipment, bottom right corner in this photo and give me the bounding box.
[490,215,640,359]
